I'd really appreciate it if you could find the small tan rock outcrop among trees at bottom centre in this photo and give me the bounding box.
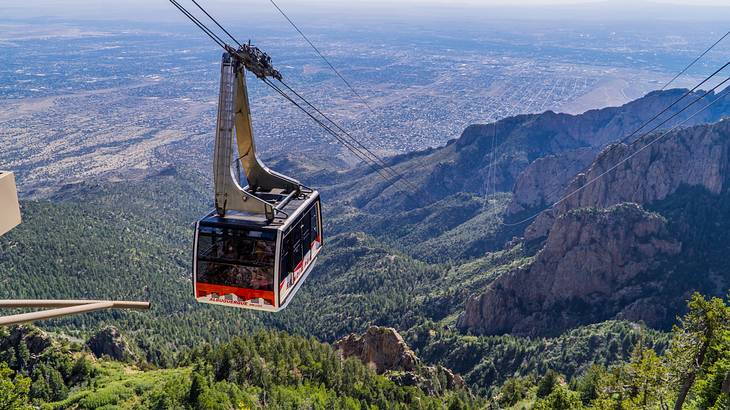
[334,326,466,394]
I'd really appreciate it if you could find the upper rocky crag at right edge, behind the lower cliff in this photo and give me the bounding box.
[525,120,730,240]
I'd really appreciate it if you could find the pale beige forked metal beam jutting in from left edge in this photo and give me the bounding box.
[0,299,150,326]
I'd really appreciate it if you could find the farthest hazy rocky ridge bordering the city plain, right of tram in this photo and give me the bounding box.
[326,89,730,213]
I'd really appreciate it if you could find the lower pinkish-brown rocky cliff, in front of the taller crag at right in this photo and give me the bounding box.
[458,204,681,336]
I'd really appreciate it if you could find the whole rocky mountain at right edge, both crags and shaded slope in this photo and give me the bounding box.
[459,121,730,335]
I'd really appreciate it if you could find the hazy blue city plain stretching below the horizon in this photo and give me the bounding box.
[0,21,727,197]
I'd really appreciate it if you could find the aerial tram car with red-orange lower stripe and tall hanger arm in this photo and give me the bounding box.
[193,44,323,312]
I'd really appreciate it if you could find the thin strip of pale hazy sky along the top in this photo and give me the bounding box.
[2,0,730,22]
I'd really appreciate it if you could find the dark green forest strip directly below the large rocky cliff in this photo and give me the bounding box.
[408,321,668,395]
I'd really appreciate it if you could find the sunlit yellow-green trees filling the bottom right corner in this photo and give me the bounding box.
[495,293,730,410]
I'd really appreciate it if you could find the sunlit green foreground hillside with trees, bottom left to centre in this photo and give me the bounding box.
[0,327,472,409]
